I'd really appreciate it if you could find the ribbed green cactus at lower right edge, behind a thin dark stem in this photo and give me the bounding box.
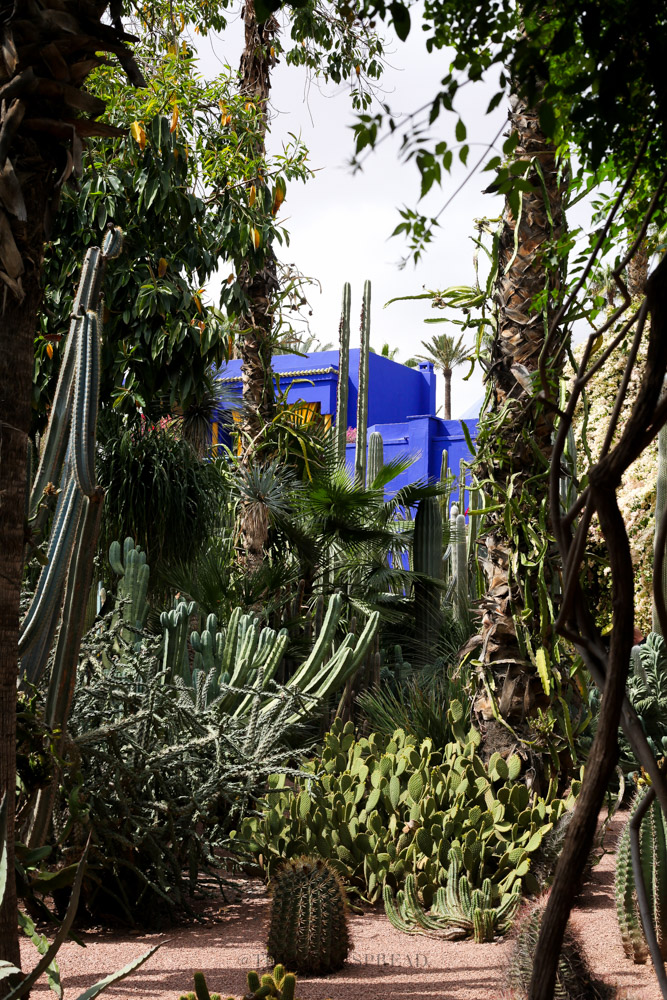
[616,791,667,963]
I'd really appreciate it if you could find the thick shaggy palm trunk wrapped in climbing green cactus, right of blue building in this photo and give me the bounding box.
[475,98,564,751]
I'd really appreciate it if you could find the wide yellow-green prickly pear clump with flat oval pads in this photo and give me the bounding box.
[240,716,578,907]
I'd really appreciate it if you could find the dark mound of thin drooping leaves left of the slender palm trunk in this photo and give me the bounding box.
[97,411,226,577]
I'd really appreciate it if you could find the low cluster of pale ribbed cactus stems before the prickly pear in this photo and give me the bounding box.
[383,848,521,944]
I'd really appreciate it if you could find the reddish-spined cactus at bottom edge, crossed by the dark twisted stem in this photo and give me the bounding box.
[507,907,616,1000]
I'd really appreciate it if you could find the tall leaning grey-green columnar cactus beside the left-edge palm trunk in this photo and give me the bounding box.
[19,228,123,847]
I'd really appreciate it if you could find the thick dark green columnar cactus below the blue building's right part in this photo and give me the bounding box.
[413,497,443,660]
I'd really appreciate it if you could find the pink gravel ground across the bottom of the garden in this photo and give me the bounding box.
[18,817,660,1000]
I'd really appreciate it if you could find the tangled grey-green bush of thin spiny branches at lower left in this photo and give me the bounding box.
[56,615,306,926]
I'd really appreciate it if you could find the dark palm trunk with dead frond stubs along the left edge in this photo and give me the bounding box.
[0,0,145,966]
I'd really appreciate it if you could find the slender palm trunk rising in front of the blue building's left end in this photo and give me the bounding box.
[239,0,278,572]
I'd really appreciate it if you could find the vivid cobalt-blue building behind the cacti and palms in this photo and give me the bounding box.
[212,348,477,504]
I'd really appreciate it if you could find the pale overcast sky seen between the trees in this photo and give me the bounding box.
[197,8,506,418]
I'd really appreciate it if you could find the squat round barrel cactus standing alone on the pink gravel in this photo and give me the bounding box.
[267,858,349,974]
